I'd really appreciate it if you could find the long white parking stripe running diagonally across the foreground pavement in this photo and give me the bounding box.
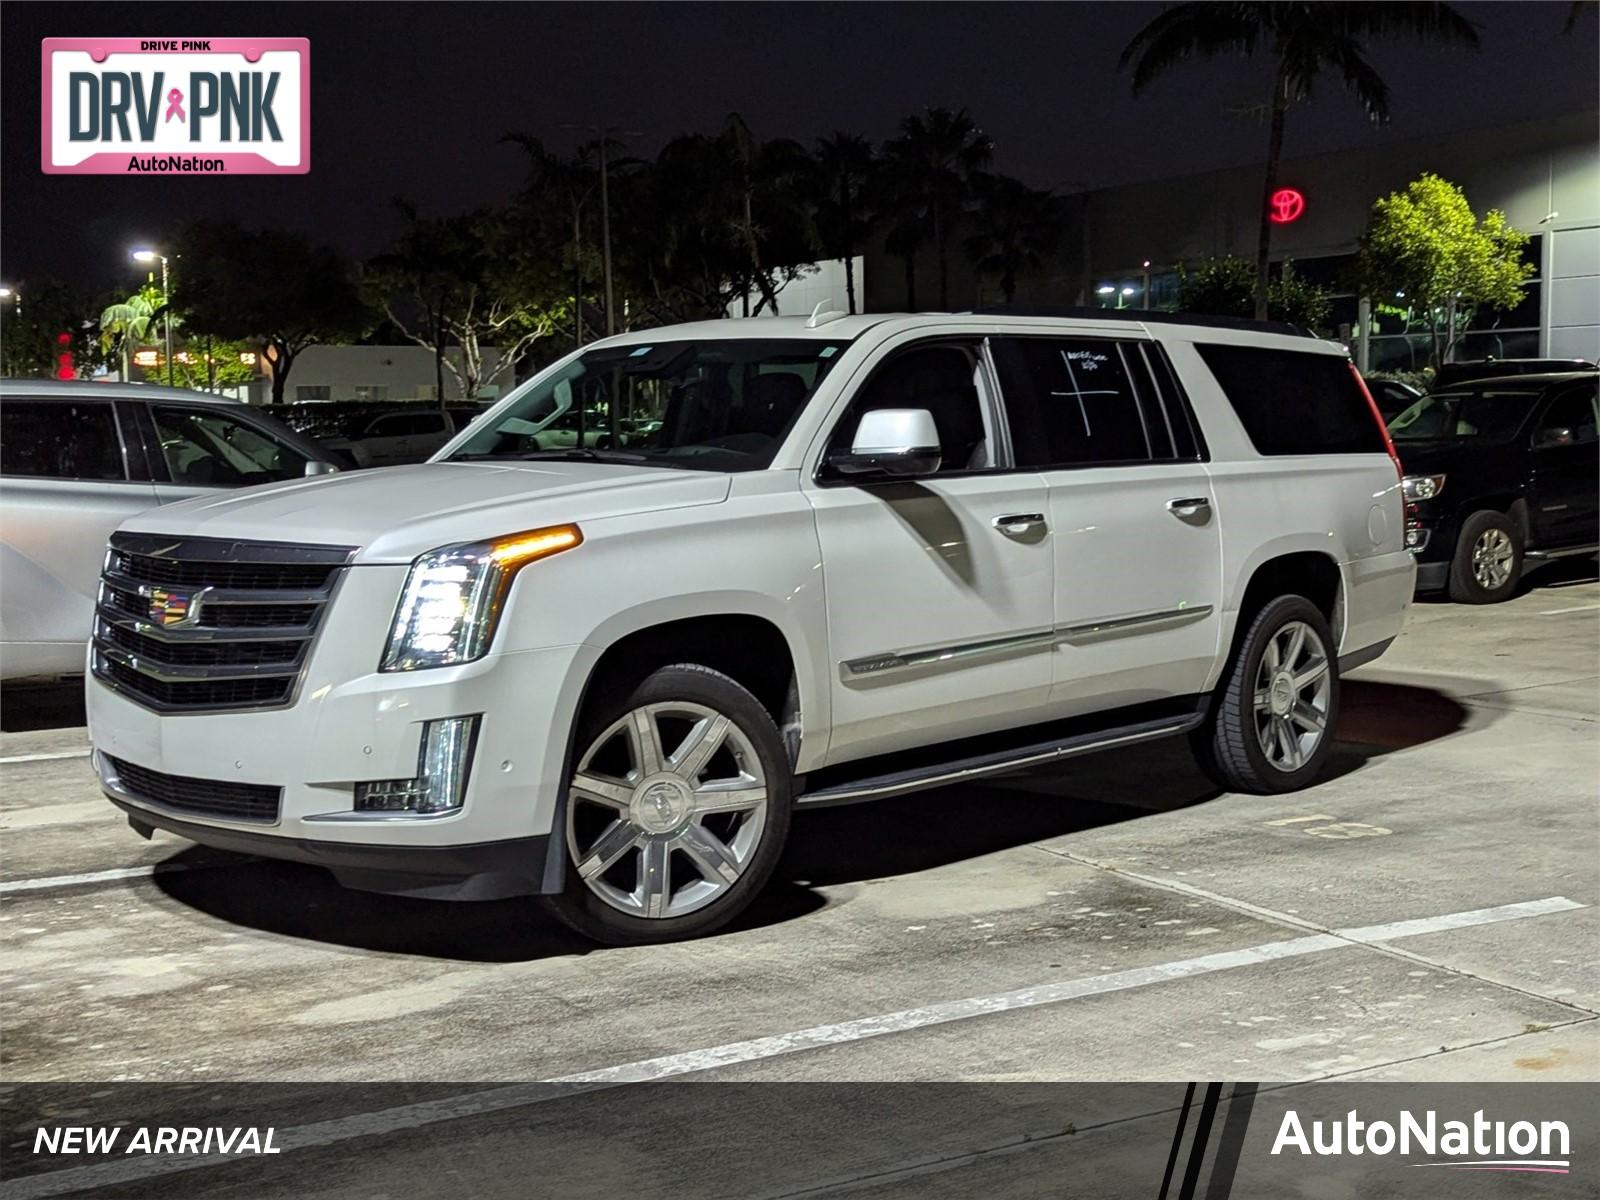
[0,896,1587,1200]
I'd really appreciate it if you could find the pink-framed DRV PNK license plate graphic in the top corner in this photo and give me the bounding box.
[40,37,310,174]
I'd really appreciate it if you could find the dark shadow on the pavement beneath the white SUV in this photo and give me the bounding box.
[155,680,1467,963]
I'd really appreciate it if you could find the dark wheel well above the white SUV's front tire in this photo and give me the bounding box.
[584,613,795,726]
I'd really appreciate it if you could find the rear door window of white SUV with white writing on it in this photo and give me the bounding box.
[994,338,1173,467]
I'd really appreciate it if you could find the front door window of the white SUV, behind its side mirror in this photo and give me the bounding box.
[824,342,994,475]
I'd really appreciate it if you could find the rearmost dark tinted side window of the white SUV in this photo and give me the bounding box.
[1195,346,1387,454]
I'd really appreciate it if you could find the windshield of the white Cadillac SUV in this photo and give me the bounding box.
[448,338,848,470]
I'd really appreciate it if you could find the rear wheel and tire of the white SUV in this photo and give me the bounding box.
[1190,595,1339,795]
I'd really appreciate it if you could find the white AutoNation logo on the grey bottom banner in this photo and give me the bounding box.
[1272,1109,1571,1174]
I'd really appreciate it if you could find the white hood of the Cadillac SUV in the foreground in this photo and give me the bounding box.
[126,461,731,563]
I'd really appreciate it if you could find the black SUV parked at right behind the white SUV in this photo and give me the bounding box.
[1389,370,1600,605]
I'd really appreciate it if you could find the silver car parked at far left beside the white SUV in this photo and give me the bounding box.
[0,379,336,680]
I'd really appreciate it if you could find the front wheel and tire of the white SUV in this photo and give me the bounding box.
[544,662,790,946]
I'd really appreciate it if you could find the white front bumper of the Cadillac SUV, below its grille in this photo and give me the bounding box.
[85,566,600,898]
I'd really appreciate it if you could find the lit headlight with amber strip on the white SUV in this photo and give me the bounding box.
[379,525,584,670]
